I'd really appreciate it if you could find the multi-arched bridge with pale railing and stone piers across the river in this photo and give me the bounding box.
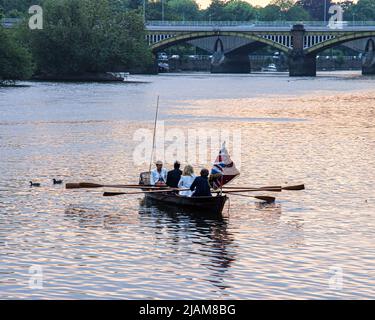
[146,21,375,76]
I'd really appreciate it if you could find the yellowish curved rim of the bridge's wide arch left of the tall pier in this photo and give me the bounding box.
[151,31,291,53]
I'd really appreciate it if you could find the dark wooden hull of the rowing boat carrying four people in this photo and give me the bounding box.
[145,192,228,216]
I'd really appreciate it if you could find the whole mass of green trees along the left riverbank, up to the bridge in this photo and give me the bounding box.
[0,0,152,84]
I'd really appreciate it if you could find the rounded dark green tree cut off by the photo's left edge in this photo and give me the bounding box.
[0,26,34,85]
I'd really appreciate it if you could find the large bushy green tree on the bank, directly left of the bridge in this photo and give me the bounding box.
[23,0,152,74]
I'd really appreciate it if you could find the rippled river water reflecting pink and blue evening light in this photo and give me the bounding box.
[0,72,375,299]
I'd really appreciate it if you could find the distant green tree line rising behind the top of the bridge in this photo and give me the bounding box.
[0,0,375,21]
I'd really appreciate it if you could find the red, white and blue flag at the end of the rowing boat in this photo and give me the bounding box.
[210,142,240,190]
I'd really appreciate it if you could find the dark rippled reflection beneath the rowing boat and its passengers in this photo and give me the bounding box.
[139,198,236,290]
